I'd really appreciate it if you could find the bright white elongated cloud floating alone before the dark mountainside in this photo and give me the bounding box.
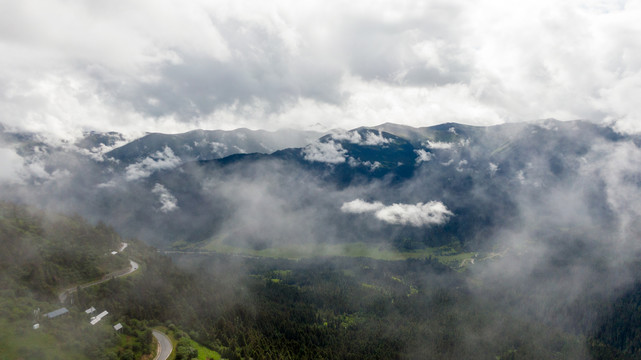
[341,199,454,227]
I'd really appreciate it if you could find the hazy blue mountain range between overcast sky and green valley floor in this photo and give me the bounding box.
[3,120,639,253]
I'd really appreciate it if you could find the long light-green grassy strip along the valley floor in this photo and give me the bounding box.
[199,238,475,269]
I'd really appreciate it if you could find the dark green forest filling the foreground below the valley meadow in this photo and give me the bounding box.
[0,203,641,359]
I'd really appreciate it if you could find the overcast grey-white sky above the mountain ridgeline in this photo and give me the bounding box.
[0,0,641,137]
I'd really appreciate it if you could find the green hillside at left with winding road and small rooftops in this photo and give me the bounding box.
[0,202,151,360]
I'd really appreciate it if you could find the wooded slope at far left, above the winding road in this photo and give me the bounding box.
[0,202,128,300]
